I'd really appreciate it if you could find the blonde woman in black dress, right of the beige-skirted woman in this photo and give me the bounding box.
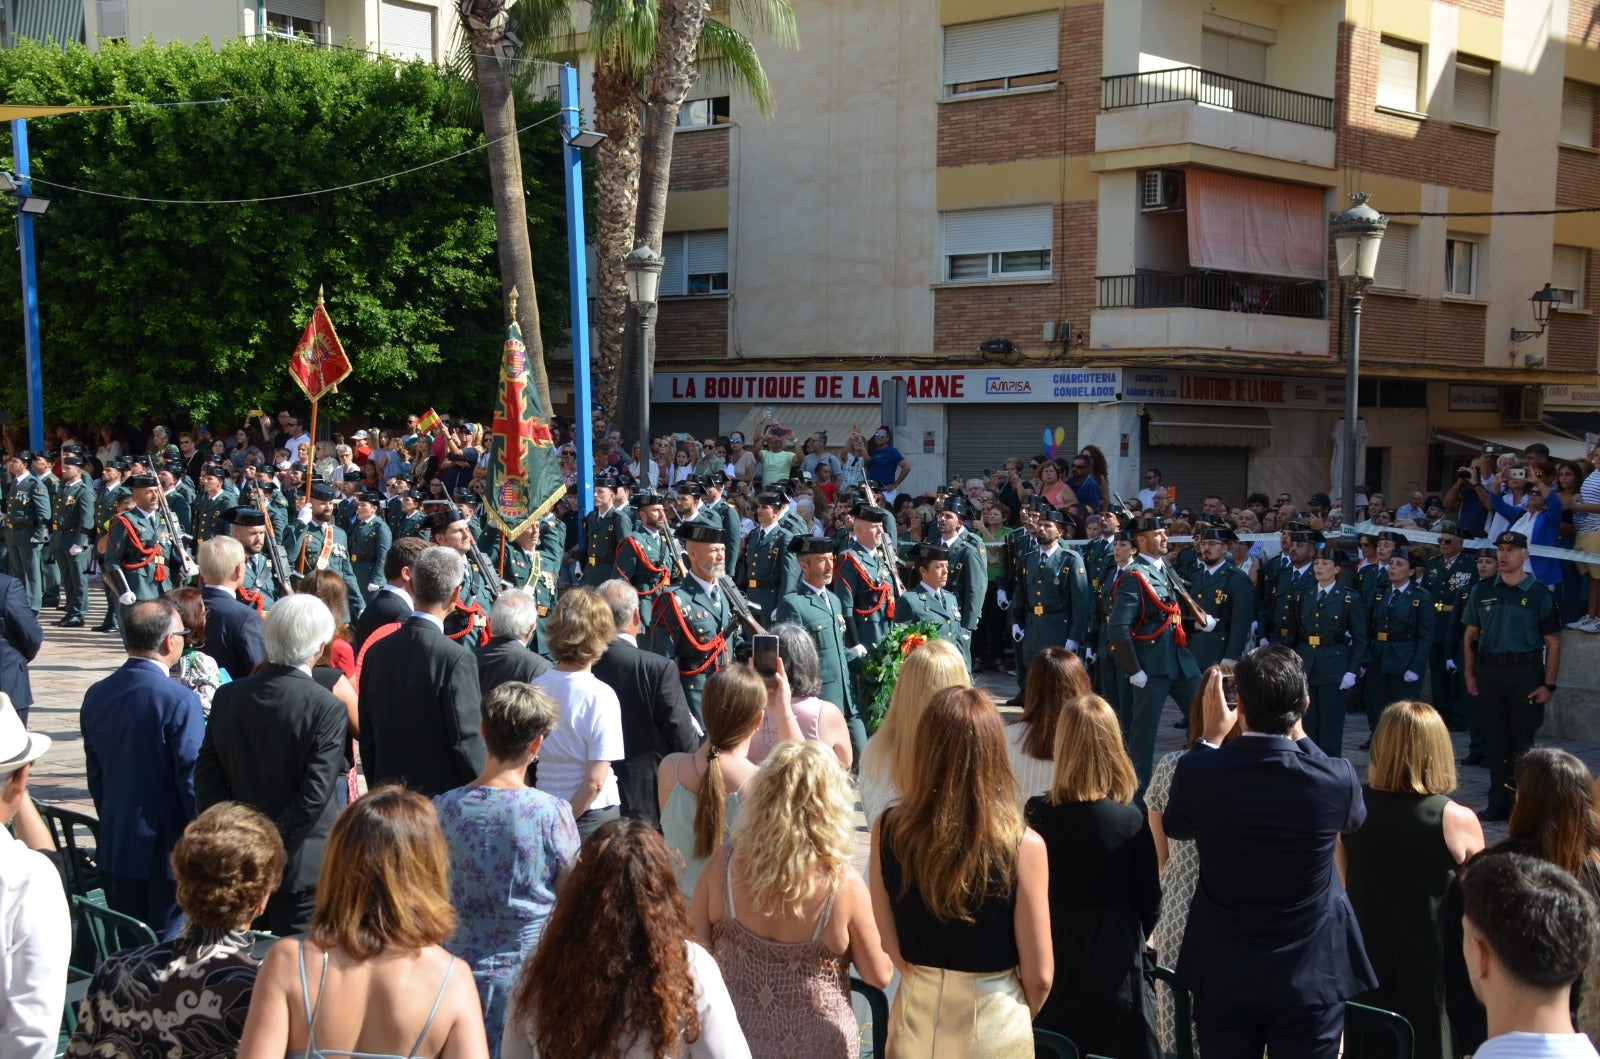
[1027,694,1162,1059]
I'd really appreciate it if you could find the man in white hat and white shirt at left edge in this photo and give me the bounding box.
[0,694,72,1059]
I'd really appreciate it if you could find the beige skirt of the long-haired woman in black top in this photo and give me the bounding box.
[888,965,1034,1059]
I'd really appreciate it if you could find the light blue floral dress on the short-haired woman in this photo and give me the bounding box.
[434,787,578,1057]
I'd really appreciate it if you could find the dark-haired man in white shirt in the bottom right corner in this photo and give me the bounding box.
[1461,853,1600,1059]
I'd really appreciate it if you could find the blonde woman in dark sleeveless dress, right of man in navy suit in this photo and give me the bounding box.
[1339,701,1483,1056]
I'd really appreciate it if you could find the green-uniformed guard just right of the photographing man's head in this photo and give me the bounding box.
[1288,530,1366,757]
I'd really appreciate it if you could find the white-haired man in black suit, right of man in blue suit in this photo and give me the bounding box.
[195,598,349,937]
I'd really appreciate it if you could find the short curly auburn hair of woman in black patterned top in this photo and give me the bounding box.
[173,801,286,929]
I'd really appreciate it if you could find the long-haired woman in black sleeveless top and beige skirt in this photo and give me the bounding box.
[869,688,1054,1059]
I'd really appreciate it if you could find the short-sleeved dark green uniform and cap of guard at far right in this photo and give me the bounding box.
[1464,530,1562,819]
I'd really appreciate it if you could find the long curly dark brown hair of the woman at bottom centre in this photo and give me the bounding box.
[507,819,701,1059]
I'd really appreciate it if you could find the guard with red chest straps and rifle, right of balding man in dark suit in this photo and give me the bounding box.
[656,522,739,720]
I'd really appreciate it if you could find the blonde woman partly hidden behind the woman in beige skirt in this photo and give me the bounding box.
[856,640,973,824]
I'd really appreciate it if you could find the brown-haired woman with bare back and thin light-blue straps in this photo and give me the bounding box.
[238,784,488,1059]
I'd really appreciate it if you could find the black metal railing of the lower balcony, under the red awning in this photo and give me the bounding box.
[1098,270,1328,320]
